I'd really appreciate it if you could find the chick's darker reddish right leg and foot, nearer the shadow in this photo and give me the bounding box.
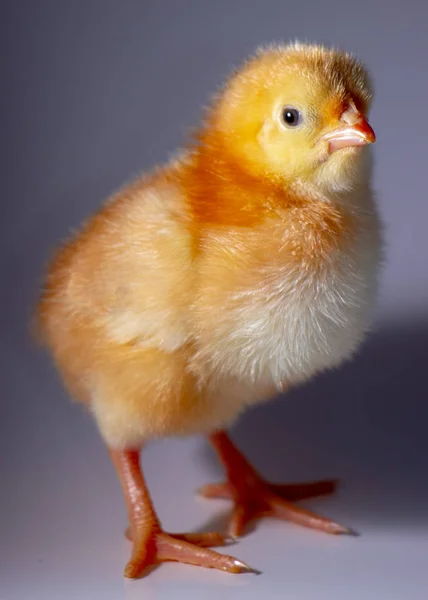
[199,432,352,536]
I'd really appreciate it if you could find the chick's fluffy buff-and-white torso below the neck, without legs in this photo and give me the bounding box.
[44,155,382,446]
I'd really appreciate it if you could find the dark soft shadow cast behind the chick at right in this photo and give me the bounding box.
[196,322,428,526]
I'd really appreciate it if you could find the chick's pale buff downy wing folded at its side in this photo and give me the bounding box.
[41,175,192,351]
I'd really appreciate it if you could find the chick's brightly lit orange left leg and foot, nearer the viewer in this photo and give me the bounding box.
[109,448,252,578]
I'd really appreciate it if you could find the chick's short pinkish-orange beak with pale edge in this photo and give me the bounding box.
[321,106,376,154]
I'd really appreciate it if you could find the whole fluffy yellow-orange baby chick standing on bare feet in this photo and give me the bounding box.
[38,44,381,577]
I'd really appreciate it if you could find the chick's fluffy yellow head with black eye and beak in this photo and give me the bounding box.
[211,44,375,190]
